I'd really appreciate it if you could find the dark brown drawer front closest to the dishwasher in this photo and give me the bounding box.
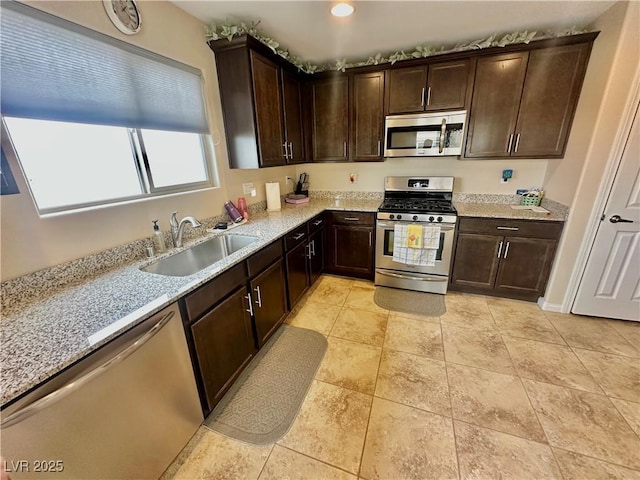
[184,262,247,322]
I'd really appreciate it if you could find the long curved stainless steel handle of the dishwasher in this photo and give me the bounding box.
[0,311,175,428]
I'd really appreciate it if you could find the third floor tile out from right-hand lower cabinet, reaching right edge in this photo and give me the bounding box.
[523,380,640,469]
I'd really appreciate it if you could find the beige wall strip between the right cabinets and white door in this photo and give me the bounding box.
[545,1,640,306]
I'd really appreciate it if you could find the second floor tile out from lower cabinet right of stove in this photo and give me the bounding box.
[502,335,604,393]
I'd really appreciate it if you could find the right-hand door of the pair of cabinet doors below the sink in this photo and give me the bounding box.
[250,259,289,347]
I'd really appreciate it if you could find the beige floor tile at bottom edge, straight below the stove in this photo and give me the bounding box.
[360,398,458,480]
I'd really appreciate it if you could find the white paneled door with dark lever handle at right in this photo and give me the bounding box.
[571,107,640,322]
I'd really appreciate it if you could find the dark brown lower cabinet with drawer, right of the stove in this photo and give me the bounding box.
[450,218,563,301]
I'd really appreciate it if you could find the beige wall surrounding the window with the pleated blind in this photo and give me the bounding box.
[0,0,295,280]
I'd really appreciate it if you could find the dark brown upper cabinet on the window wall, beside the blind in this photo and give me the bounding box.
[209,35,305,168]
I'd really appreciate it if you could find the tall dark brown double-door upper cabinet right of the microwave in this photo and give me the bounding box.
[464,42,592,158]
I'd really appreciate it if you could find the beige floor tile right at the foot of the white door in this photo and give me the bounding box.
[545,312,639,358]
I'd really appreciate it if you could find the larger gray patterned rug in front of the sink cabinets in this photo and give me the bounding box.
[204,325,327,445]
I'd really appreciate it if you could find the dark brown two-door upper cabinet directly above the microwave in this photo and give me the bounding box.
[387,58,473,115]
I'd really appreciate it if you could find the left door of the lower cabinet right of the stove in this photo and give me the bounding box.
[451,232,504,290]
